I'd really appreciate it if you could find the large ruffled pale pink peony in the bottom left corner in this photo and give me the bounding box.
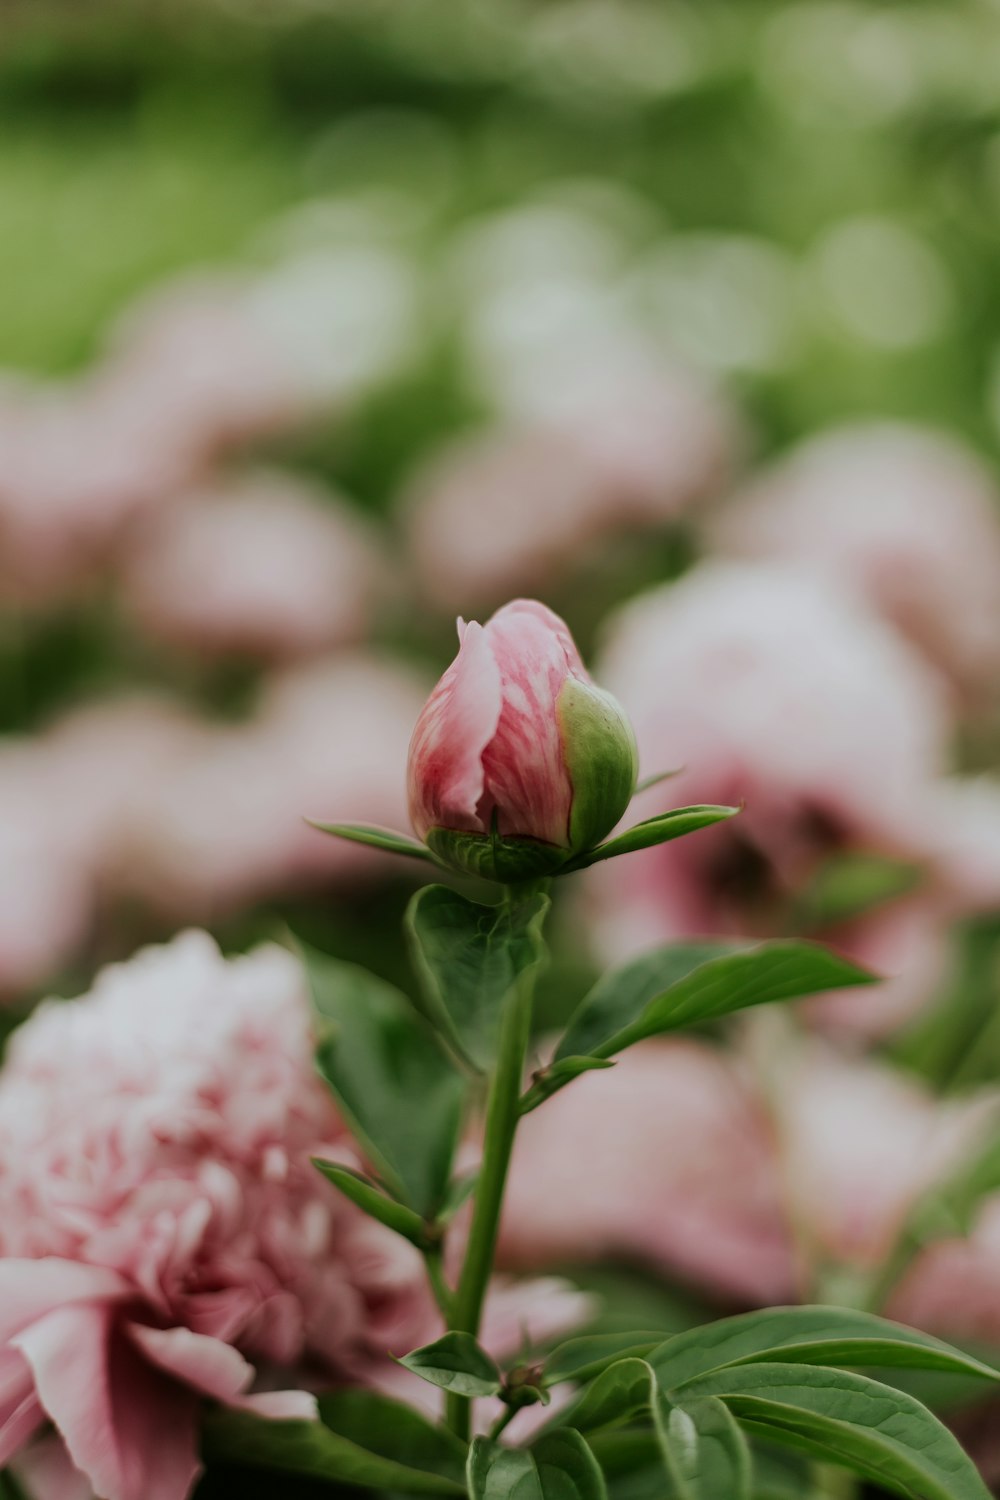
[0,932,586,1500]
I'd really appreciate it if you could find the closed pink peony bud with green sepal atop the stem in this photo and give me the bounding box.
[408,599,637,881]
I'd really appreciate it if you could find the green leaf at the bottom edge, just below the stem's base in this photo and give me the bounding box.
[468,1428,607,1500]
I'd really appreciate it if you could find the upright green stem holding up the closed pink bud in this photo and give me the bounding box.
[448,890,535,1439]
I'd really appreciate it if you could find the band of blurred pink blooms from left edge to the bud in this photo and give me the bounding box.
[0,654,423,998]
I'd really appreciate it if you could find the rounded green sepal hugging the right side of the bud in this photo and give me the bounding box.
[556,677,639,852]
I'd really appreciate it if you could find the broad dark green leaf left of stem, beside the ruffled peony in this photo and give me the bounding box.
[303,950,465,1218]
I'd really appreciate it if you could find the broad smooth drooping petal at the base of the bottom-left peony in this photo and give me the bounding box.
[13,1307,199,1500]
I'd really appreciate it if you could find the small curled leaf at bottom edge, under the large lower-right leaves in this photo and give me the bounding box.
[652,1394,751,1500]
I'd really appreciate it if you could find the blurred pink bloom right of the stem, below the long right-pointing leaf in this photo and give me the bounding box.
[501,1041,795,1302]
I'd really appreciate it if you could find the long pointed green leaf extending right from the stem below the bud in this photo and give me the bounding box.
[556,942,874,1061]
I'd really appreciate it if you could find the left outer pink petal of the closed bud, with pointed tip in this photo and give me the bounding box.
[408,623,502,839]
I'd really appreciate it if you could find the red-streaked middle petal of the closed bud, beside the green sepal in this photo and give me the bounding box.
[480,600,578,845]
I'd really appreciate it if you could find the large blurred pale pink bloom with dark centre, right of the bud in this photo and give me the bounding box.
[588,563,1000,1034]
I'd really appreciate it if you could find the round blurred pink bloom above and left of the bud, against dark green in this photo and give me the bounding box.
[121,473,382,660]
